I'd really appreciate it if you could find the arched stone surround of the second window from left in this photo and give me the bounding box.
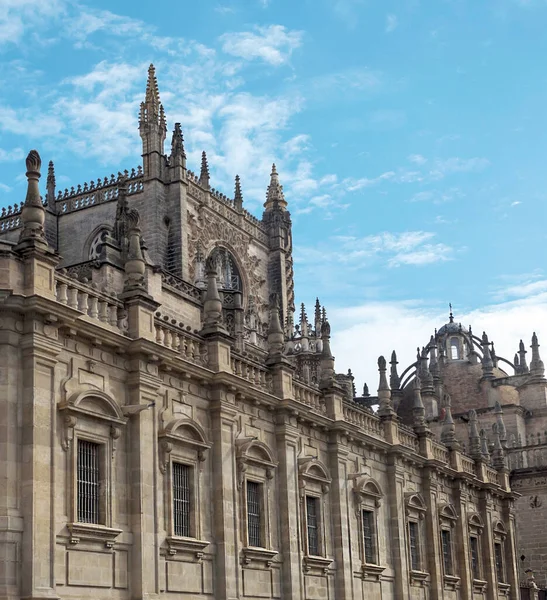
[158,418,211,560]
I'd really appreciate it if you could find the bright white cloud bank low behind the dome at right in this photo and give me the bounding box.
[327,290,547,394]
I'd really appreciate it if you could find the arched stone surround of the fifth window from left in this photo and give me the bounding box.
[353,475,386,578]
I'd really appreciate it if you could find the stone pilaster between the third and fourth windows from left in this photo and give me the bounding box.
[276,412,304,600]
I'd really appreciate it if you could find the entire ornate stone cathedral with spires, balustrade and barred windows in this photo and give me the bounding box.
[0,66,528,600]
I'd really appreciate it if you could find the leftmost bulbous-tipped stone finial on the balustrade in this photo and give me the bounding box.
[19,150,47,246]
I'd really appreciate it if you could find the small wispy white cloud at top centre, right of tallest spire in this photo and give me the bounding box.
[220,25,303,67]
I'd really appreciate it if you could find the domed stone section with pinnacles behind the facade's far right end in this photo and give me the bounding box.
[384,313,547,589]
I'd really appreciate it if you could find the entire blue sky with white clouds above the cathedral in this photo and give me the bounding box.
[0,0,547,387]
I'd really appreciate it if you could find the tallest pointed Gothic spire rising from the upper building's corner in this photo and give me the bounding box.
[139,65,167,179]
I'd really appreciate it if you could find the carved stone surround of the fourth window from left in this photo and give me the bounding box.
[298,456,333,574]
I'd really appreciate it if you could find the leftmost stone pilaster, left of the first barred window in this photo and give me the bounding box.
[19,317,61,600]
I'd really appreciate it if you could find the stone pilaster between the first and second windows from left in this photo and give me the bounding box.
[127,356,161,600]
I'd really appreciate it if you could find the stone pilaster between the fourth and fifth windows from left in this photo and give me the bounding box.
[329,433,354,598]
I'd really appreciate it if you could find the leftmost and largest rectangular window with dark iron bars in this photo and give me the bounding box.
[77,440,100,524]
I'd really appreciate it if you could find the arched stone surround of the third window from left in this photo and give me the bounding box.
[235,437,278,567]
